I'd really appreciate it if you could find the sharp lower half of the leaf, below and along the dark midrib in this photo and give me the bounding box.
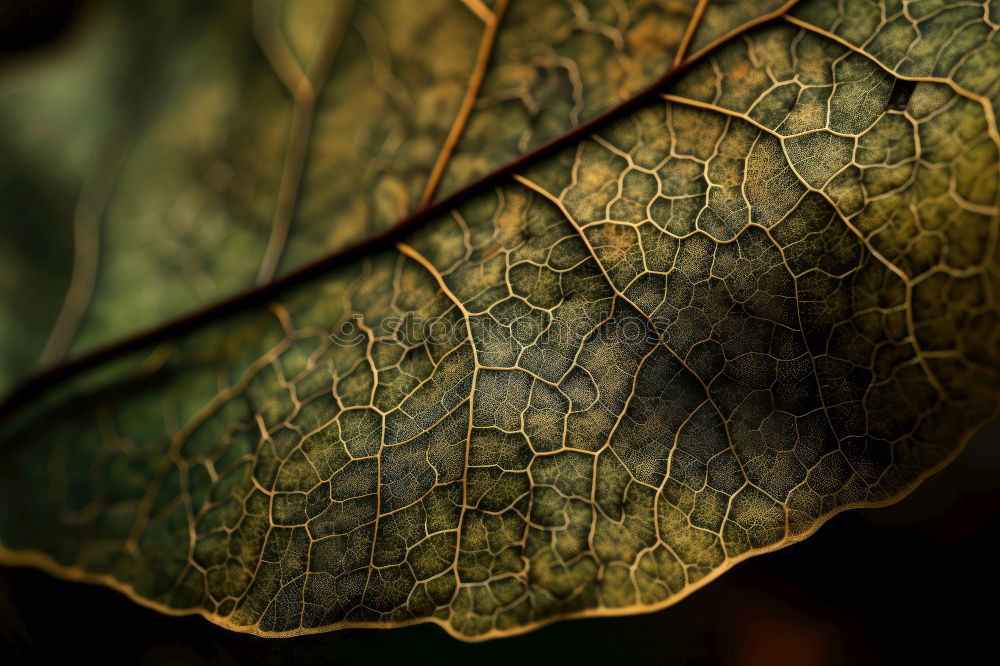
[0,0,1000,639]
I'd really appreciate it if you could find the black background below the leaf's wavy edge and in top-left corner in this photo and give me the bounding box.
[0,0,1000,666]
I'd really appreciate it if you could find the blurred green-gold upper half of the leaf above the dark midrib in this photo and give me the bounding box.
[0,0,781,390]
